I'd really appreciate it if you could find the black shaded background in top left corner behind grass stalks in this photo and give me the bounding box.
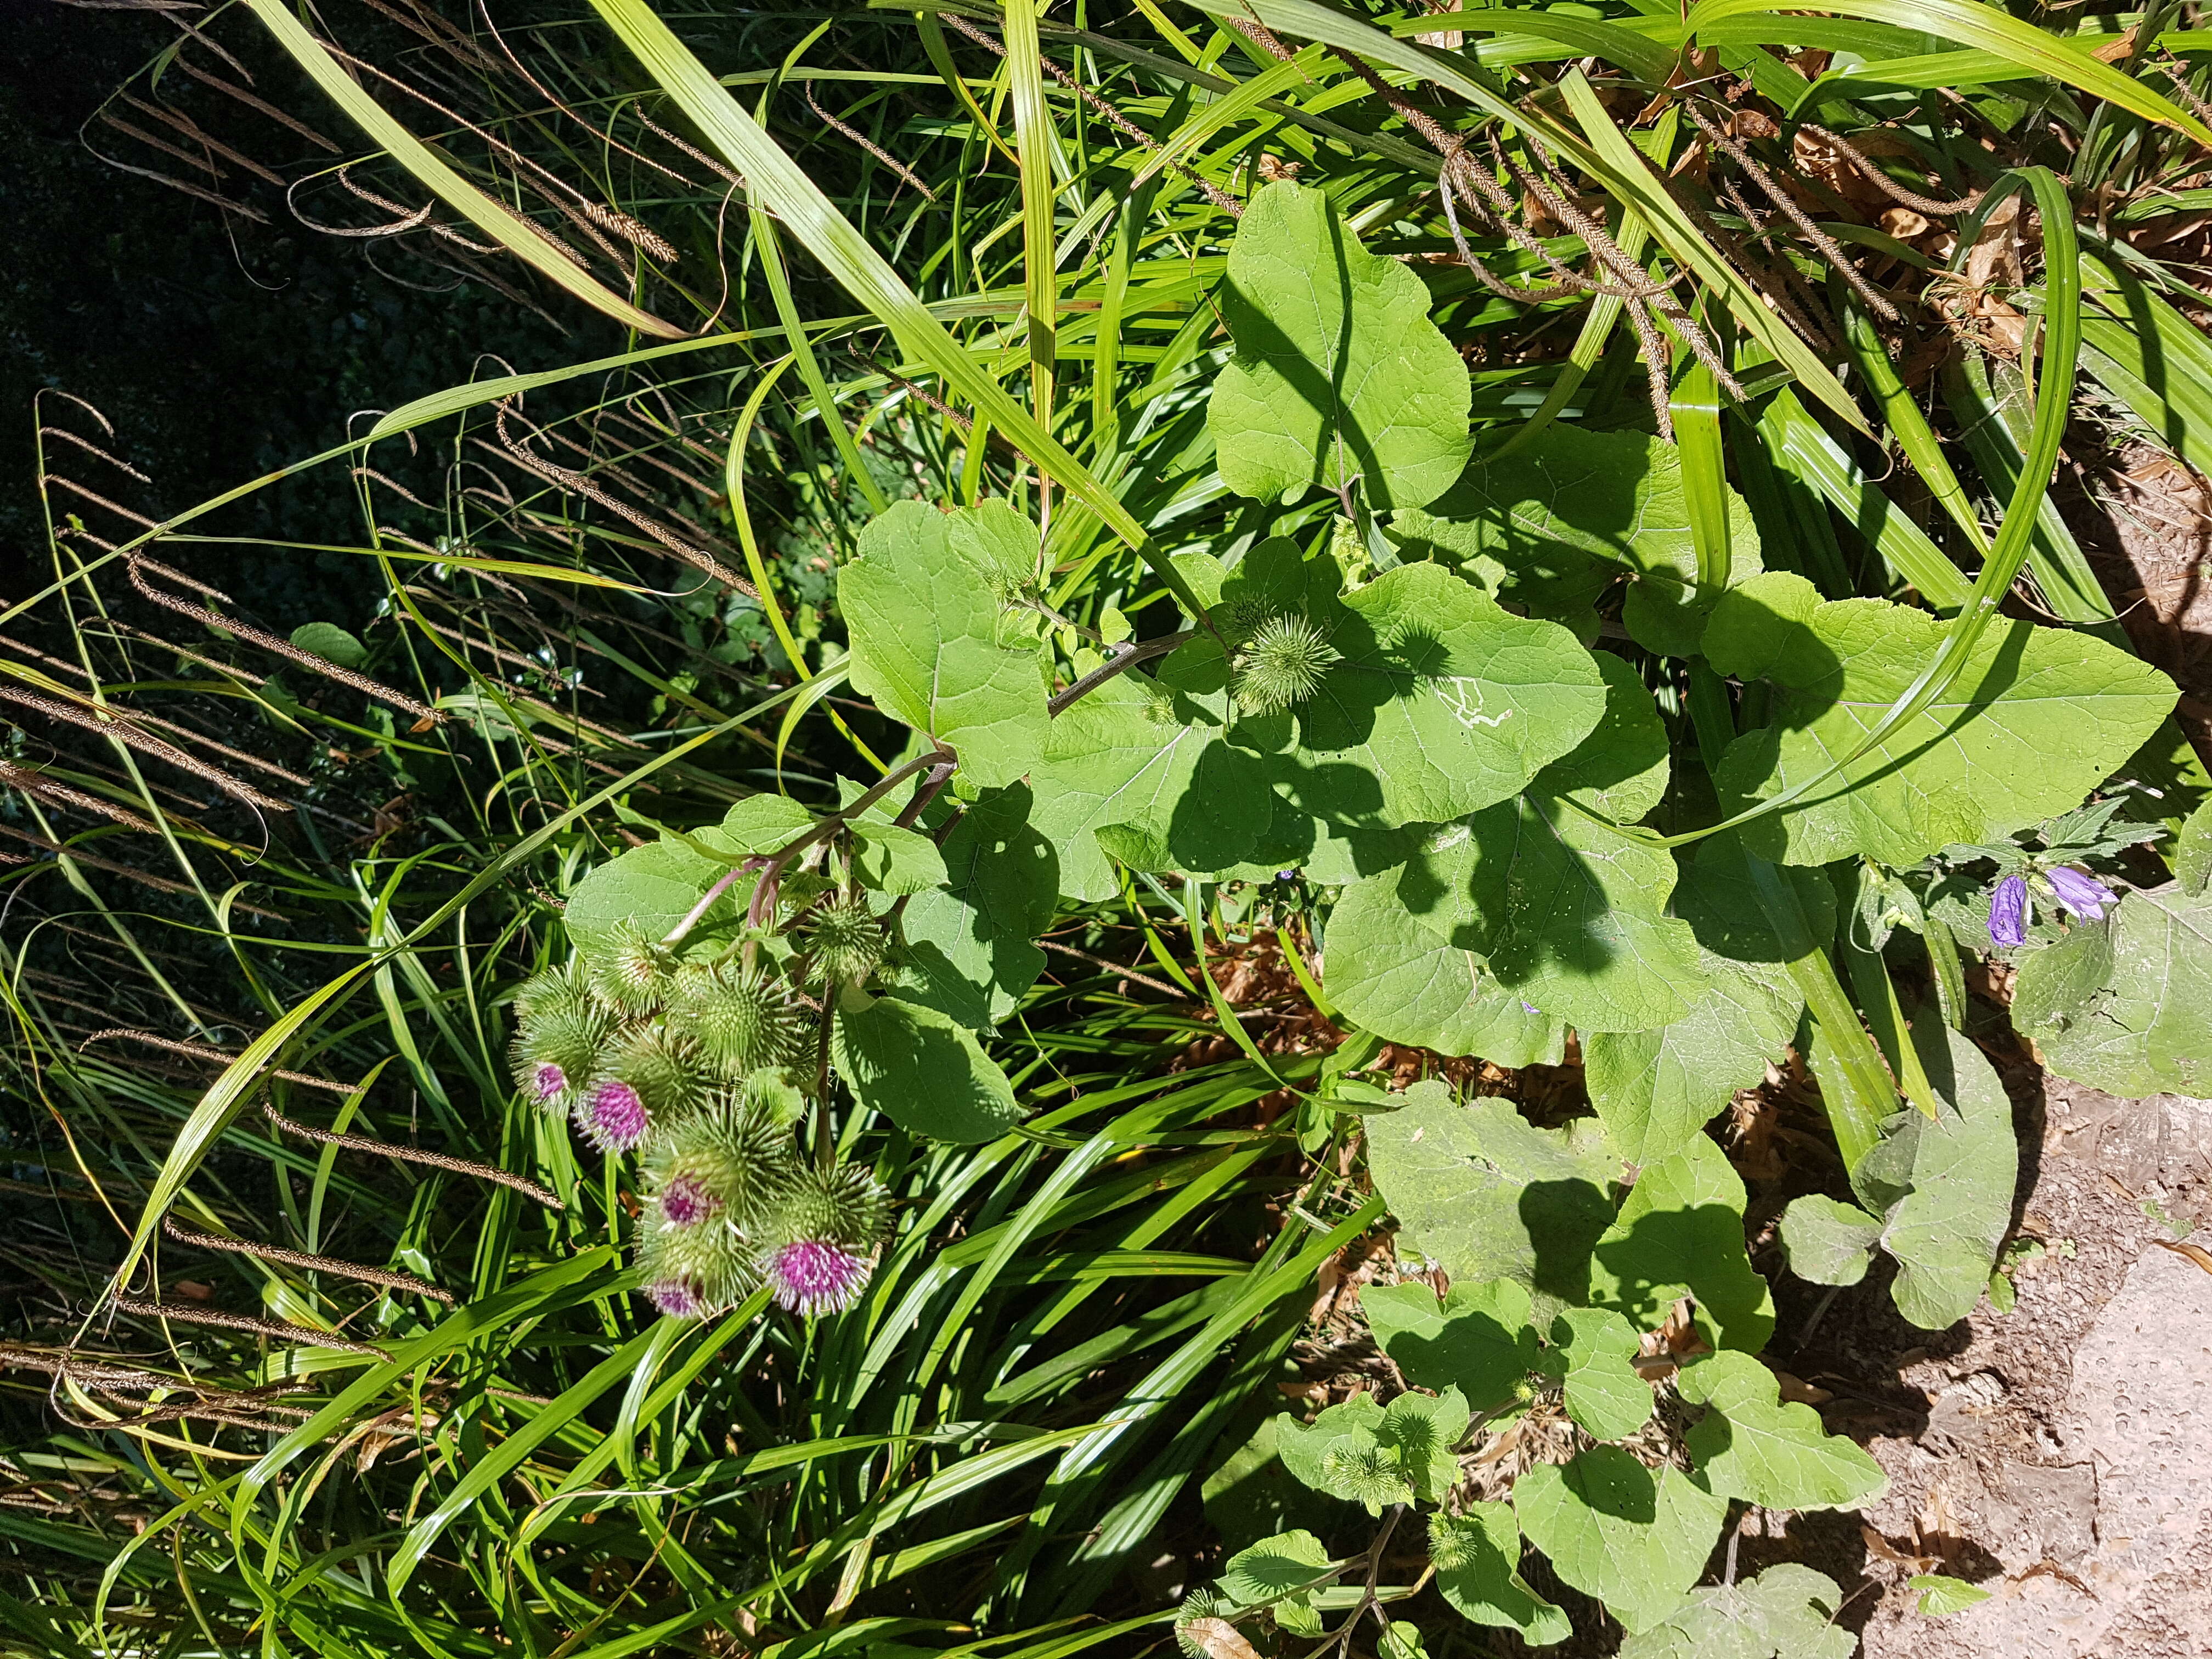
[0,0,619,619]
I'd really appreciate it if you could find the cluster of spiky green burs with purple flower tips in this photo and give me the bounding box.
[515,898,889,1318]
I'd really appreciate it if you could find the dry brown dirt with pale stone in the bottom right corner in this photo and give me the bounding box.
[1769,1068,2212,1659]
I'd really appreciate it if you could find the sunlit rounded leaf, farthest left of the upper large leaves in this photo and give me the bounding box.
[836,500,1051,787]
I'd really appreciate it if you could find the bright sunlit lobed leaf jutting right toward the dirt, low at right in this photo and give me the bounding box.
[1677,1354,1889,1509]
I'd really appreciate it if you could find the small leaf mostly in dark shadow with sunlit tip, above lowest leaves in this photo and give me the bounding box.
[1586,1135,1774,1354]
